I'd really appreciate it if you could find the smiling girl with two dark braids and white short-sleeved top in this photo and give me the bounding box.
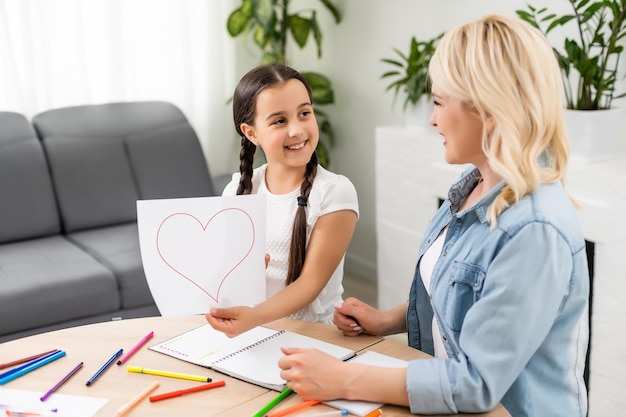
[206,63,359,337]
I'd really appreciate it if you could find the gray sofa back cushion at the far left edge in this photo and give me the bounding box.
[0,112,61,243]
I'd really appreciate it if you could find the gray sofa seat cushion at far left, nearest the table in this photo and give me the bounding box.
[0,236,120,334]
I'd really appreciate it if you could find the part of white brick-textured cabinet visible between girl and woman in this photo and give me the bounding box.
[375,127,462,309]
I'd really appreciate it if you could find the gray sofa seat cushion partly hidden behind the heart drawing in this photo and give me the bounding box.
[67,223,154,309]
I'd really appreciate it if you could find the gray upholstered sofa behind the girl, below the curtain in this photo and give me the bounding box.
[0,102,223,342]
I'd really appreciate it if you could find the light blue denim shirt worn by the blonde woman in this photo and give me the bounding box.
[407,169,589,417]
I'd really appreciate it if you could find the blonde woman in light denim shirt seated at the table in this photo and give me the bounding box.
[279,15,589,417]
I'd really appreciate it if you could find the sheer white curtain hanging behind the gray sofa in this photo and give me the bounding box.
[0,0,236,175]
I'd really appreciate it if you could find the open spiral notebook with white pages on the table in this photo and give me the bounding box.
[150,324,355,391]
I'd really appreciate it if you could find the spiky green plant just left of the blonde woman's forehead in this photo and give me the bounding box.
[380,33,443,125]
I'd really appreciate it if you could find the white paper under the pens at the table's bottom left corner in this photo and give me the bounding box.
[0,388,109,417]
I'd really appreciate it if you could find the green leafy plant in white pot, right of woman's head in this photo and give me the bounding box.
[516,0,626,161]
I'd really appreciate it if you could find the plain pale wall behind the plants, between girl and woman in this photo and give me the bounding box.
[229,0,624,281]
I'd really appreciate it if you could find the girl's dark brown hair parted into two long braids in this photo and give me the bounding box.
[233,63,318,285]
